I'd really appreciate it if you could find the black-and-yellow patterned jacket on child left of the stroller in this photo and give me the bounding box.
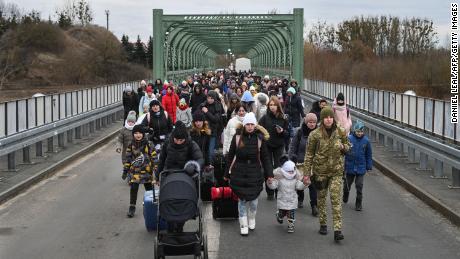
[123,138,157,184]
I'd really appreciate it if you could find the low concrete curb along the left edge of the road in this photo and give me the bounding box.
[0,129,120,205]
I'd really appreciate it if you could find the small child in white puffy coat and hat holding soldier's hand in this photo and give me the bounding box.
[268,155,307,233]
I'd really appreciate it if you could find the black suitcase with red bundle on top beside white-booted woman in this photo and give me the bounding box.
[211,186,239,219]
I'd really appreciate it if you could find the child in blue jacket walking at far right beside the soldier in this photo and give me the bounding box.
[343,120,372,211]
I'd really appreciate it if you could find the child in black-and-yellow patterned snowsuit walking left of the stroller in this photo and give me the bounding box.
[124,125,157,218]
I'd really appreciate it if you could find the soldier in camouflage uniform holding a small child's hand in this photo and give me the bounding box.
[304,106,350,241]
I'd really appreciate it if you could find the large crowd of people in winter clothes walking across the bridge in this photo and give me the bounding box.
[116,71,372,241]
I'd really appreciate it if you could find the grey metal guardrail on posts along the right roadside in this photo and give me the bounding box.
[302,89,460,188]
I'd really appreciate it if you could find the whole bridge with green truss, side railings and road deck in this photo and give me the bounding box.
[0,9,460,258]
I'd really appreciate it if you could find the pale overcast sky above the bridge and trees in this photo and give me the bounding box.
[9,0,451,46]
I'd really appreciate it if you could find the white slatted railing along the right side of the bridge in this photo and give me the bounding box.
[305,79,460,144]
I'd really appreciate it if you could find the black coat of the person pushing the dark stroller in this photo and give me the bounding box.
[156,137,204,179]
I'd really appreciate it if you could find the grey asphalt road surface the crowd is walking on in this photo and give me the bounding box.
[0,142,460,259]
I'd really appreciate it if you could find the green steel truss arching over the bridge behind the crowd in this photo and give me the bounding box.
[153,8,303,84]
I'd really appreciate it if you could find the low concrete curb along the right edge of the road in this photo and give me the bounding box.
[373,158,460,227]
